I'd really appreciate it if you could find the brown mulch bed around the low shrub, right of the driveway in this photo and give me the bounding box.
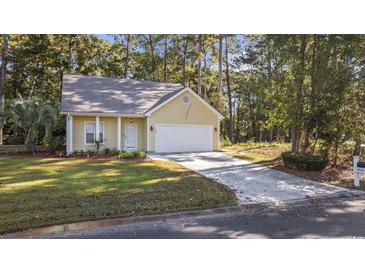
[270,162,358,188]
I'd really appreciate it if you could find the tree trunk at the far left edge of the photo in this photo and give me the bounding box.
[0,34,9,145]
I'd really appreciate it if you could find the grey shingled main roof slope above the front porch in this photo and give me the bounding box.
[61,74,184,114]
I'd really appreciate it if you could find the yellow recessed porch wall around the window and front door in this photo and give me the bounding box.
[72,116,146,152]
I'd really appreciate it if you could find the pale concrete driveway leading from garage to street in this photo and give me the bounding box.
[149,152,361,205]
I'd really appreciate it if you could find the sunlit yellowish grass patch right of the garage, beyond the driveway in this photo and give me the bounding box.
[224,142,290,165]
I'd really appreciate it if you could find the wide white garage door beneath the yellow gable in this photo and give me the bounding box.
[155,124,212,153]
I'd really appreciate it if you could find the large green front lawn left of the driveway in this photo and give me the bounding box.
[0,157,237,233]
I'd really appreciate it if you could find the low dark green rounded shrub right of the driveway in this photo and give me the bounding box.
[281,152,328,171]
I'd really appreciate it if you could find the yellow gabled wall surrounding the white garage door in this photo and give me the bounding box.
[149,91,219,151]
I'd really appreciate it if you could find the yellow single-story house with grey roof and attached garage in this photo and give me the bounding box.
[61,74,223,154]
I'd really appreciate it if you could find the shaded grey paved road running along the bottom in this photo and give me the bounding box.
[15,197,365,239]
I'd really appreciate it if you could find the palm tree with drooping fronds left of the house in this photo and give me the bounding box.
[7,96,57,152]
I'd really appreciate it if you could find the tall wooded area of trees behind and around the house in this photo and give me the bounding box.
[0,34,365,163]
